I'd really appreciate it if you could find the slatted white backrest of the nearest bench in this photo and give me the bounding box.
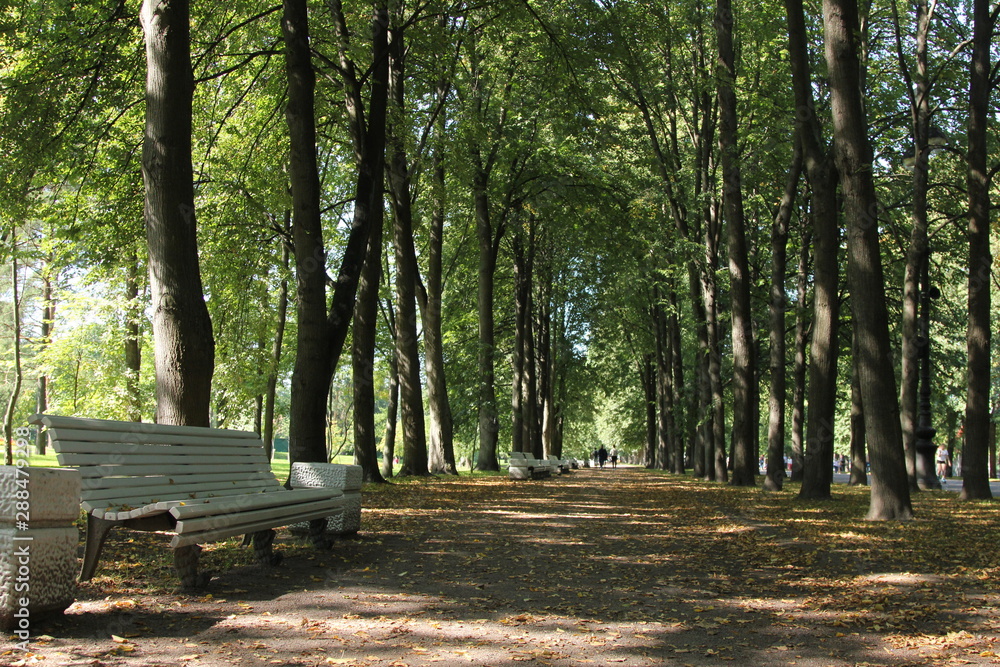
[30,415,282,511]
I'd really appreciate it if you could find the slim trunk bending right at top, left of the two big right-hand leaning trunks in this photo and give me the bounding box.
[764,141,802,491]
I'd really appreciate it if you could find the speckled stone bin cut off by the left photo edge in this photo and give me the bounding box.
[0,466,80,633]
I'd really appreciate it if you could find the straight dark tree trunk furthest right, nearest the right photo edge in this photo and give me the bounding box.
[961,0,995,500]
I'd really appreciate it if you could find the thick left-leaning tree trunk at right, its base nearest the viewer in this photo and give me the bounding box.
[823,0,913,520]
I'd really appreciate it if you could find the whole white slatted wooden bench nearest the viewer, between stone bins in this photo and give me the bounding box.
[30,415,344,588]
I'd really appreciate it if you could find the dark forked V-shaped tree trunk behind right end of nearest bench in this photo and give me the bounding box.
[282,0,388,462]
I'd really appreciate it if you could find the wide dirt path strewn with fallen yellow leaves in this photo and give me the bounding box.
[0,468,1000,667]
